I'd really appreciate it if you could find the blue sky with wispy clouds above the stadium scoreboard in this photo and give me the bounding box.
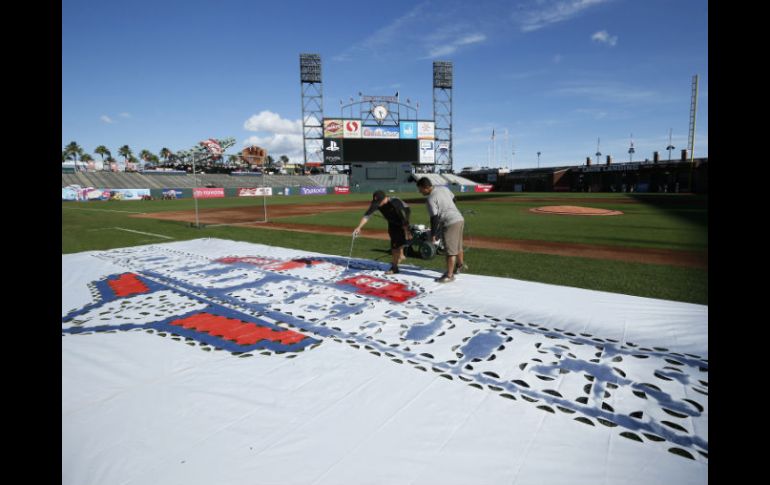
[62,0,708,170]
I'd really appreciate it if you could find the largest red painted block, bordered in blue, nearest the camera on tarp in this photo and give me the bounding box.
[171,312,305,345]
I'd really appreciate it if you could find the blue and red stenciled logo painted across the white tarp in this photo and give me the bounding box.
[62,245,708,462]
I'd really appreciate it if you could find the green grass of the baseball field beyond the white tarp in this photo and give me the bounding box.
[62,191,708,304]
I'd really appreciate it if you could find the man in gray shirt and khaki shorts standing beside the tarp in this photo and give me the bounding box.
[417,177,468,283]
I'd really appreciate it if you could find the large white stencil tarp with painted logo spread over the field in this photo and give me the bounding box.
[62,239,708,485]
